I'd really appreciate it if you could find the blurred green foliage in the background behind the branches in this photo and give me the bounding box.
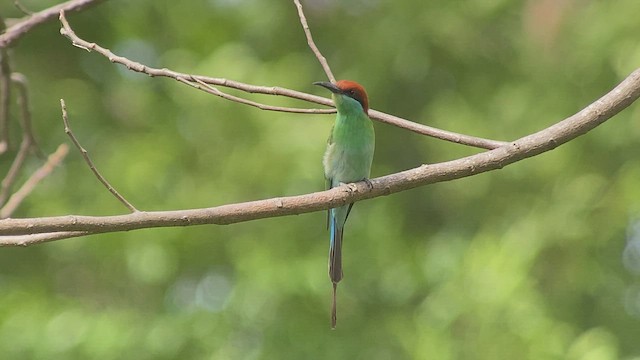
[0,0,640,360]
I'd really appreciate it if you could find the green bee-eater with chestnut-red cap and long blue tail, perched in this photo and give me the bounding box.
[313,80,375,329]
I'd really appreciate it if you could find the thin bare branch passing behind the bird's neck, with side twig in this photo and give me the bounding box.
[60,12,507,150]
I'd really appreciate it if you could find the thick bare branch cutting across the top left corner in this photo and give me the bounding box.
[0,0,104,48]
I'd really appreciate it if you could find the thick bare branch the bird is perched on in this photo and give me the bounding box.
[0,69,640,242]
